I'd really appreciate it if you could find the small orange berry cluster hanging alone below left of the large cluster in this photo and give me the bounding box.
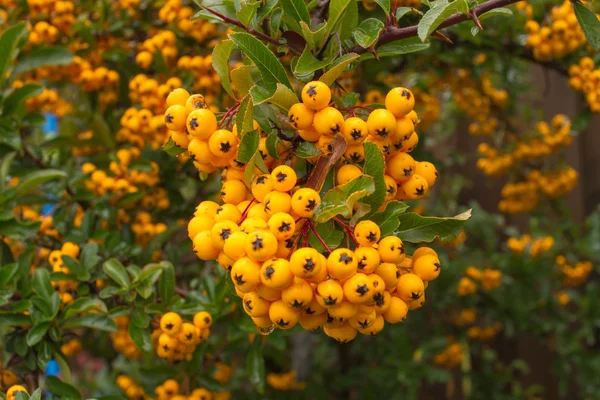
[152,311,212,361]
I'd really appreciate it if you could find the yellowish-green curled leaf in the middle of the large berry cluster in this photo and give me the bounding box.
[315,175,375,223]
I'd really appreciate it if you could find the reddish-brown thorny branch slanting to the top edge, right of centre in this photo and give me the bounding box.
[348,0,522,54]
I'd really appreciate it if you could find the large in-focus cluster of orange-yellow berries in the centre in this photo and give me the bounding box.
[165,81,440,341]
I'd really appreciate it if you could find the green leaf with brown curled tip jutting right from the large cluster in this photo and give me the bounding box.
[397,210,471,243]
